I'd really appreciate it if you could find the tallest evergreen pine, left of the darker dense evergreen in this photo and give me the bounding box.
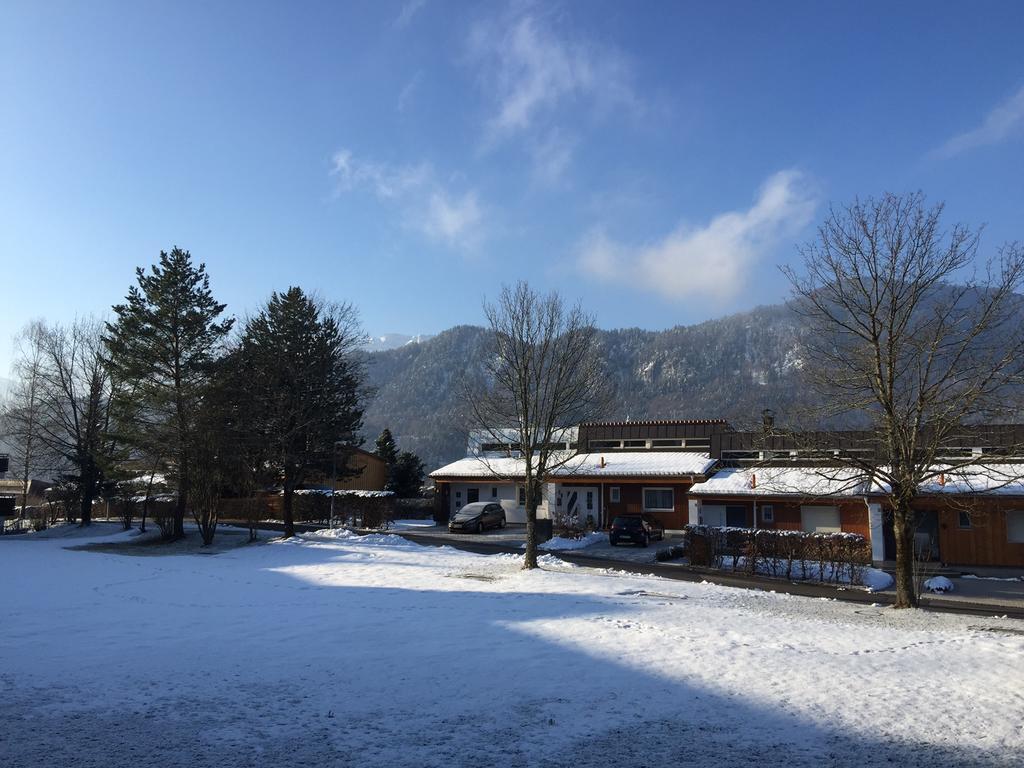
[104,248,233,538]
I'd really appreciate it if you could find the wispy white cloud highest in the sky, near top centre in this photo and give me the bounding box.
[469,6,639,156]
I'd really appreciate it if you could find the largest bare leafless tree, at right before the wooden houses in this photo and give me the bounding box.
[784,193,1024,607]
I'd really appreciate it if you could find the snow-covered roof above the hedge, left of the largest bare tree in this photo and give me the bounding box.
[689,467,867,497]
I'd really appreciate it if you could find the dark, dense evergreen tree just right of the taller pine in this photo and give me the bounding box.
[241,288,364,537]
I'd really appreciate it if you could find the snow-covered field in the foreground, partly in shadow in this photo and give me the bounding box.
[0,531,1024,768]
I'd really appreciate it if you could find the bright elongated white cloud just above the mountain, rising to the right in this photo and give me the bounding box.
[578,170,816,299]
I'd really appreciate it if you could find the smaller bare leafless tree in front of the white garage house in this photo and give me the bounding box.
[466,282,609,568]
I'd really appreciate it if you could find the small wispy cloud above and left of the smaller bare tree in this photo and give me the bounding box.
[331,148,484,250]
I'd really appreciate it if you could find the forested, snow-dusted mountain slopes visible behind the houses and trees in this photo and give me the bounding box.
[364,305,801,470]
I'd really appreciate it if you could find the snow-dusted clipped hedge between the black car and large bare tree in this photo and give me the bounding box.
[685,525,871,584]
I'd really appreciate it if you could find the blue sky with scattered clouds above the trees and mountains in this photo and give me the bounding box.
[0,0,1024,373]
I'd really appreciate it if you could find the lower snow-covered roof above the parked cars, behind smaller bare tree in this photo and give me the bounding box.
[430,451,715,479]
